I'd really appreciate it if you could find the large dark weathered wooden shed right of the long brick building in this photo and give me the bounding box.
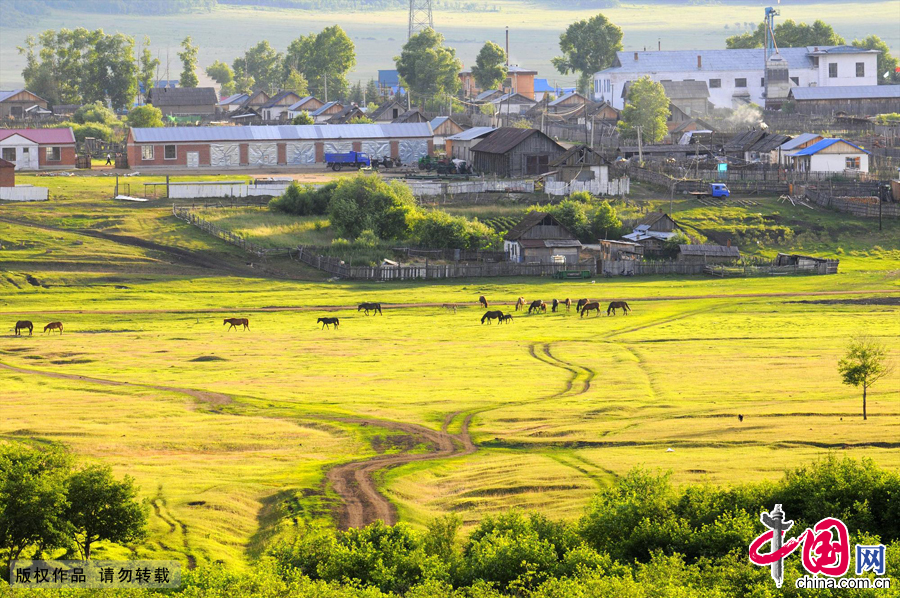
[472,127,565,177]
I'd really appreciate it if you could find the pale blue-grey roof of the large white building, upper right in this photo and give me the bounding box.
[600,46,868,74]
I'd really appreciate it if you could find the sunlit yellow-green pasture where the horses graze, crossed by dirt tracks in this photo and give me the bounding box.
[0,177,900,567]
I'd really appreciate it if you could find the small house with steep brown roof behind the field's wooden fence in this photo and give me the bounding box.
[503,212,581,266]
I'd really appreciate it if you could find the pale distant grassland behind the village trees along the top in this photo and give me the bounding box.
[0,0,900,89]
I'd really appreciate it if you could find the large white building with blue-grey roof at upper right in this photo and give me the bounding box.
[593,46,879,109]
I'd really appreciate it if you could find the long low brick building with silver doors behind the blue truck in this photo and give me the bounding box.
[127,123,434,171]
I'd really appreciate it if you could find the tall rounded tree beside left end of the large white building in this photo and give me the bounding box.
[551,14,622,93]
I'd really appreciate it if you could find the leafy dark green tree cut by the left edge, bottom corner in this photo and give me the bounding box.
[0,443,70,563]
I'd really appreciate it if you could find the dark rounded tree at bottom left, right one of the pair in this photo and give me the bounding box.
[65,465,147,560]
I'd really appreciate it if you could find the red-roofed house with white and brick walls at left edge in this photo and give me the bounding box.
[0,127,75,170]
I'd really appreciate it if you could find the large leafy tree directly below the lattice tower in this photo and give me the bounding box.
[394,28,462,104]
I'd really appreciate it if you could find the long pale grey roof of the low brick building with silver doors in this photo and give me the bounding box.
[131,123,434,143]
